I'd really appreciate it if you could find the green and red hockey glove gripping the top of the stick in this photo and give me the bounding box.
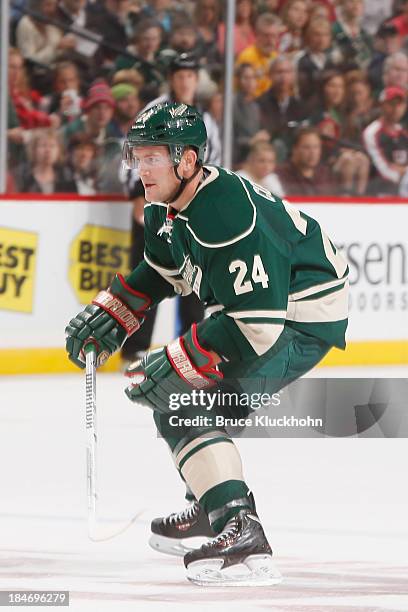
[65,274,151,368]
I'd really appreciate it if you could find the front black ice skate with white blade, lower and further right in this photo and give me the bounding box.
[184,509,282,586]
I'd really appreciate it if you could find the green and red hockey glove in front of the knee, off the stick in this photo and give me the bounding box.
[125,323,223,413]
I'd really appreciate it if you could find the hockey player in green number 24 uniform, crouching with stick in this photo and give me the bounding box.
[66,104,348,585]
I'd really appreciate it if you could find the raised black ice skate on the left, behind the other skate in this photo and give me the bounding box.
[149,501,214,557]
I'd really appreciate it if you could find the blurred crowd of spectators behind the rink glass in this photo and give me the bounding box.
[8,0,408,197]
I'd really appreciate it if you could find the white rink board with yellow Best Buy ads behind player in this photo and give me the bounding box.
[0,199,408,373]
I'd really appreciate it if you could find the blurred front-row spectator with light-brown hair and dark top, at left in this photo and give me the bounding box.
[18,128,76,194]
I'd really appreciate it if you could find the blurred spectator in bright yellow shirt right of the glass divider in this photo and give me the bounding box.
[237,13,282,96]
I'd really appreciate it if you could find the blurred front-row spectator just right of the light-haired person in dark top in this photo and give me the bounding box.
[69,134,99,195]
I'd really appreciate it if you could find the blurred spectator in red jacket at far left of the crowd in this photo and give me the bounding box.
[8,47,60,130]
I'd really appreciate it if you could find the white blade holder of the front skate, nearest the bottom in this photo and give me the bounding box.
[187,555,283,586]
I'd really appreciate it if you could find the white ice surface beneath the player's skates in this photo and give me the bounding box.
[0,370,408,612]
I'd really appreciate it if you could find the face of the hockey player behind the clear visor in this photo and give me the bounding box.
[132,146,180,202]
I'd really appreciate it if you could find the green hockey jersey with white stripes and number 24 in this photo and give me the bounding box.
[127,166,348,360]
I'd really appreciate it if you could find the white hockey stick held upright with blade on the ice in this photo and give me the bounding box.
[84,341,143,542]
